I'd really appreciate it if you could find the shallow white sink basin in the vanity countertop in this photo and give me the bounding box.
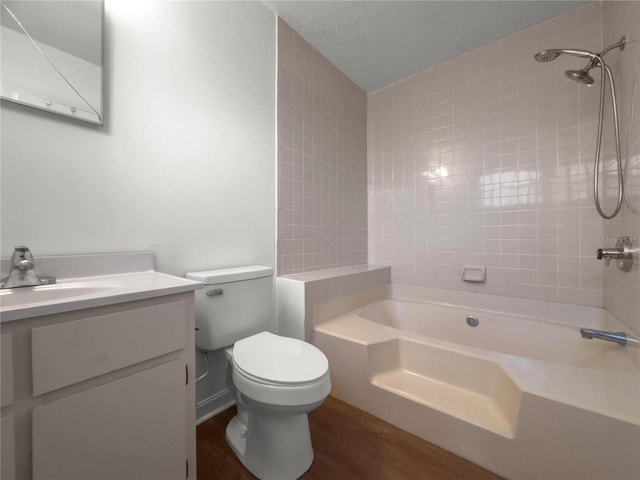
[0,282,119,308]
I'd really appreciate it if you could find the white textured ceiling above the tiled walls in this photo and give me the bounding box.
[262,0,588,92]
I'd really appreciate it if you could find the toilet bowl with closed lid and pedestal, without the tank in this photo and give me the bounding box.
[226,332,331,480]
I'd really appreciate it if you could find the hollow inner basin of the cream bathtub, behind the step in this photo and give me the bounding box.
[358,299,639,372]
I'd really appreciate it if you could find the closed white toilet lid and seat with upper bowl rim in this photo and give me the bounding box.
[232,332,331,406]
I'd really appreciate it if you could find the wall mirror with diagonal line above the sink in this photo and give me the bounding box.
[0,0,104,125]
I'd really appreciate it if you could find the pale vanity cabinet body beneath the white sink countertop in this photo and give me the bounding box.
[0,291,196,480]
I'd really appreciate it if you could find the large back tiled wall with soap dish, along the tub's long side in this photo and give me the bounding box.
[367,3,608,306]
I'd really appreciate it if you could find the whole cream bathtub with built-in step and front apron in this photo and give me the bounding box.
[314,286,640,480]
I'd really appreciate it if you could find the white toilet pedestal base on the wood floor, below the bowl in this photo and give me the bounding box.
[226,404,313,480]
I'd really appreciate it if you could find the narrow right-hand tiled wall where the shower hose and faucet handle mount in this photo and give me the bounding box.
[596,1,640,335]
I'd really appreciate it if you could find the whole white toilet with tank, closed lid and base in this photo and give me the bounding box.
[186,266,331,480]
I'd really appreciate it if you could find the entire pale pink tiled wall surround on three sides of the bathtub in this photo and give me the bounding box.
[278,1,640,326]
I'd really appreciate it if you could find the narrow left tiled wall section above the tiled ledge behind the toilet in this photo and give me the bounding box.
[277,19,367,275]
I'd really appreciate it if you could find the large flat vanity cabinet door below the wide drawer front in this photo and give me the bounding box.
[33,359,187,480]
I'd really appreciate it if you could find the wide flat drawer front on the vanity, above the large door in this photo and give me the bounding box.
[31,300,186,395]
